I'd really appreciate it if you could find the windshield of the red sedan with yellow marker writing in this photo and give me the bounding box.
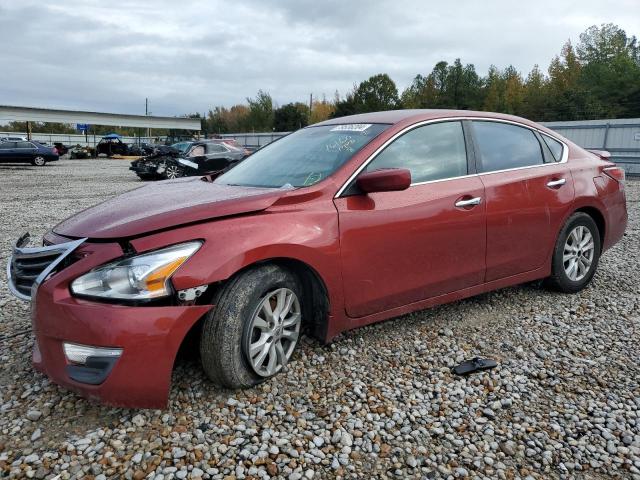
[215,123,389,188]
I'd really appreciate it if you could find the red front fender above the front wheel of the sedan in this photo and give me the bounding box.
[126,208,343,311]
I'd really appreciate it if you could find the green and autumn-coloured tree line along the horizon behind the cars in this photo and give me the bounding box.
[0,24,640,135]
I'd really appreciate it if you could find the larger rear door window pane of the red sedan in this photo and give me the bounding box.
[472,121,544,172]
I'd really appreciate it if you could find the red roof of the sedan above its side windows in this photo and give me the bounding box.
[313,108,540,128]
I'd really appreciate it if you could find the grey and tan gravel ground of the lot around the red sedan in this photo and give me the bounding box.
[0,160,640,480]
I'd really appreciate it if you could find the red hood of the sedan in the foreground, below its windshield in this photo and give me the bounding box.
[53,177,287,239]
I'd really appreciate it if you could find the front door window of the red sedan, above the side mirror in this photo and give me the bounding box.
[367,122,467,183]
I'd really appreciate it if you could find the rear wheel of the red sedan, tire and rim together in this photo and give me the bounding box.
[545,212,601,293]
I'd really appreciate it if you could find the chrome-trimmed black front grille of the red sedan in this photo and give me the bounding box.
[7,233,86,300]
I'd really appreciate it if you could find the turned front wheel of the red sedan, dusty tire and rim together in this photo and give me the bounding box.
[200,265,303,388]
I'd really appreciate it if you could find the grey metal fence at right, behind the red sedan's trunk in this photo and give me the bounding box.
[543,118,640,175]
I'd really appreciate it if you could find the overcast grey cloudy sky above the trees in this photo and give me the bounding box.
[0,0,640,115]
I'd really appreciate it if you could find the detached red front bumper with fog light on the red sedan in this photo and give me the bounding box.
[8,234,212,408]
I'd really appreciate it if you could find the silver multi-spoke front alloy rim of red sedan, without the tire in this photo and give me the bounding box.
[245,288,302,377]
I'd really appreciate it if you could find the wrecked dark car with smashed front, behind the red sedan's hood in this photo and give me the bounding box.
[129,140,247,180]
